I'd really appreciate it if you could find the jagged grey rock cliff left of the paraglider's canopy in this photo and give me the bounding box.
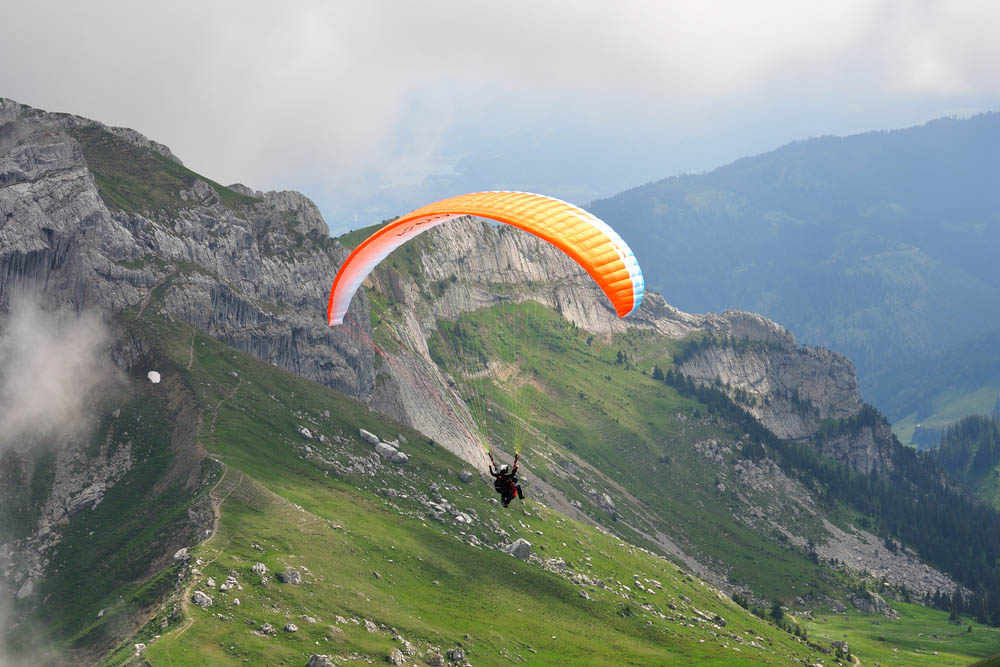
[0,99,374,399]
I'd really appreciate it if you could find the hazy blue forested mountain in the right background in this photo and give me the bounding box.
[591,113,1000,388]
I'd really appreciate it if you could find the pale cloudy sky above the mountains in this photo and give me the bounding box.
[0,0,1000,234]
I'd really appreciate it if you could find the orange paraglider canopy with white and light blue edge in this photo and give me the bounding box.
[327,192,644,326]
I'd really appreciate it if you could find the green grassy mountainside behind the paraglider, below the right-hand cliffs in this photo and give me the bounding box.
[432,303,834,600]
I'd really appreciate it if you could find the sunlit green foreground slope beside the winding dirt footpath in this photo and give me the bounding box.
[101,310,832,665]
